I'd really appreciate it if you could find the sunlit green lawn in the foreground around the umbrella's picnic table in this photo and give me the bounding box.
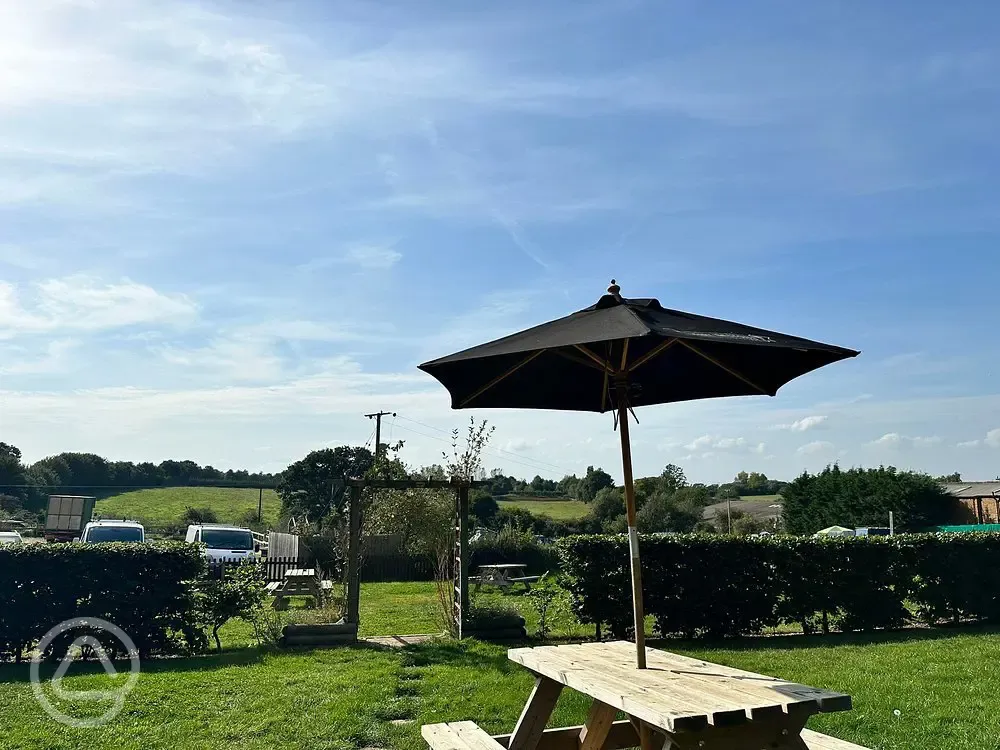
[0,630,1000,750]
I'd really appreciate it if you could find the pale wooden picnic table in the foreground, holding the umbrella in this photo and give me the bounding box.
[421,641,865,750]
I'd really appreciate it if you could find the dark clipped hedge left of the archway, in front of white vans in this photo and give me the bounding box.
[0,543,205,660]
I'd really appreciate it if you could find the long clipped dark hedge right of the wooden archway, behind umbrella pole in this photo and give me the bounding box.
[557,534,1000,637]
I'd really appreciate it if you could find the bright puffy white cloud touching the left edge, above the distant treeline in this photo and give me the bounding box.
[0,276,198,338]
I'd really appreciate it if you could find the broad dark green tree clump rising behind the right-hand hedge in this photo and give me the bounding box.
[782,464,957,534]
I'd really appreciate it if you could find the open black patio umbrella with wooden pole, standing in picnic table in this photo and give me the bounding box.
[420,280,858,669]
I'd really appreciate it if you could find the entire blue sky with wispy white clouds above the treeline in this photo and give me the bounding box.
[0,0,1000,481]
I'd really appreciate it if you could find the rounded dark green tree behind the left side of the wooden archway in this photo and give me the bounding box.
[278,446,374,528]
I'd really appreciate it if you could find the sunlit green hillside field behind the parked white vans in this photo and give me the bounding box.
[95,487,281,526]
